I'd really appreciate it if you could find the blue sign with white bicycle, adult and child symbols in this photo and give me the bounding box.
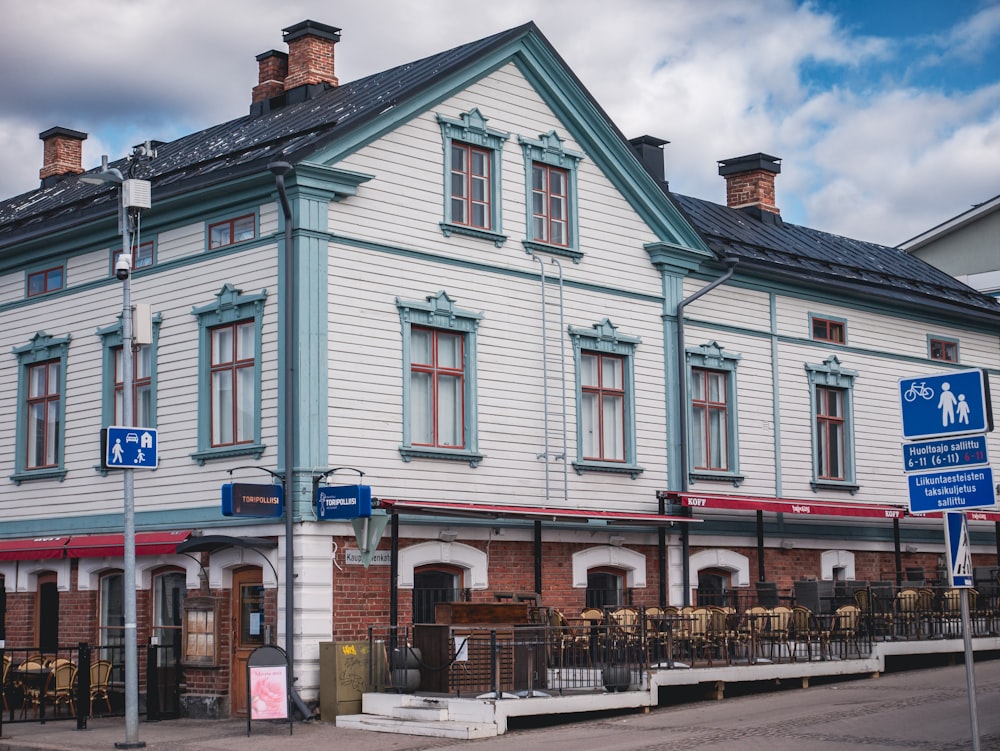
[899,370,993,439]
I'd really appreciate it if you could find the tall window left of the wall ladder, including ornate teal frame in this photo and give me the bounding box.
[396,292,482,466]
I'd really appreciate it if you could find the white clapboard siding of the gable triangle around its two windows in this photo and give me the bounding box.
[330,61,660,302]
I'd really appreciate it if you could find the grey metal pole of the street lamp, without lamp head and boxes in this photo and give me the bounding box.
[115,197,146,748]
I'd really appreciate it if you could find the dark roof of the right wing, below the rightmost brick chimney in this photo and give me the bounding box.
[668,193,1000,325]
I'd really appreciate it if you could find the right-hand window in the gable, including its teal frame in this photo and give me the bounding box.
[520,131,583,262]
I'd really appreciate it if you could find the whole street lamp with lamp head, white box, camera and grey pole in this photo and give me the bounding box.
[80,156,150,748]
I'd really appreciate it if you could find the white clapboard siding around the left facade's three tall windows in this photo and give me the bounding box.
[0,245,277,521]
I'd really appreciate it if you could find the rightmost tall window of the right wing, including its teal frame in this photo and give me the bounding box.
[806,356,858,492]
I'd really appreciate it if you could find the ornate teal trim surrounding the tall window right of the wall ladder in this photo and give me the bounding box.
[569,318,643,480]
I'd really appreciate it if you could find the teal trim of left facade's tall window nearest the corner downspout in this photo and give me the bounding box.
[191,282,267,465]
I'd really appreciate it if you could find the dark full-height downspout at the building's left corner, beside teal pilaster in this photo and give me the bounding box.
[267,162,312,720]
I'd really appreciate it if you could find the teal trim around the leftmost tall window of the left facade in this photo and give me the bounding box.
[10,331,71,485]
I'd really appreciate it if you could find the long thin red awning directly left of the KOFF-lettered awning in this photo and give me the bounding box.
[380,498,701,526]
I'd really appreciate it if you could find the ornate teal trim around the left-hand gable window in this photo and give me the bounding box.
[437,107,510,248]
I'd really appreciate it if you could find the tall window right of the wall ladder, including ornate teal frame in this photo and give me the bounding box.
[570,318,642,477]
